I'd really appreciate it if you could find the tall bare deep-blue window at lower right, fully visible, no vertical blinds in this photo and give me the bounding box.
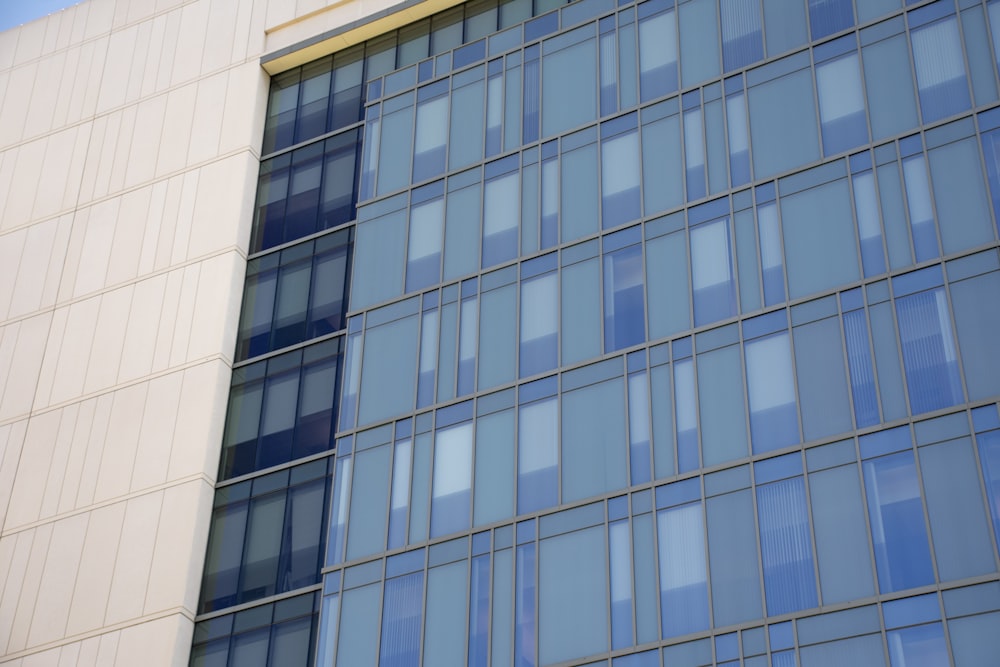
[863,452,934,593]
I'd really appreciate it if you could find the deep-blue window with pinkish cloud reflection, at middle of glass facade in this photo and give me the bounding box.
[604,245,646,352]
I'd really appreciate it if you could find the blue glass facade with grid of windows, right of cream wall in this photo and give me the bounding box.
[192,0,1000,667]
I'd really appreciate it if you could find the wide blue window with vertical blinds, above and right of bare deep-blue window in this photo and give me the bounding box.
[896,288,962,414]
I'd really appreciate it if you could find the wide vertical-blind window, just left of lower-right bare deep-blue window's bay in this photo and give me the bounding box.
[757,476,818,616]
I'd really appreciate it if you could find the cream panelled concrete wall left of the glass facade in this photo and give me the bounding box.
[0,0,268,667]
